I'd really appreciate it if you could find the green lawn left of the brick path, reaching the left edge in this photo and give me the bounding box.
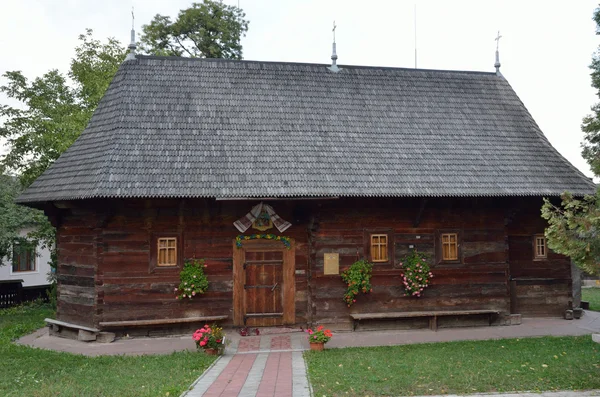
[0,304,214,397]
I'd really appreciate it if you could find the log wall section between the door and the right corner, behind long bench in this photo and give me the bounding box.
[310,199,510,325]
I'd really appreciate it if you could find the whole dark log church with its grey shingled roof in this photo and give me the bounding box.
[18,30,595,332]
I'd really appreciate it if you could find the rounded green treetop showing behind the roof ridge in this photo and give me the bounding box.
[140,0,248,59]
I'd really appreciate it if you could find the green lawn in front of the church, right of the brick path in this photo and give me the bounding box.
[305,336,600,397]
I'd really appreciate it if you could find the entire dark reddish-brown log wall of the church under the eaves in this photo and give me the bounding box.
[52,195,570,326]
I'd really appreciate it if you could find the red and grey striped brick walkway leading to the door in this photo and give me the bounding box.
[185,333,310,397]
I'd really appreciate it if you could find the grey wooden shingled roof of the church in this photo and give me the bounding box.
[19,56,595,204]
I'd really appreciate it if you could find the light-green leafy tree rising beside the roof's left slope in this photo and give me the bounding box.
[0,30,126,186]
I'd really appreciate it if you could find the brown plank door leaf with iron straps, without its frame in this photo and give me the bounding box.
[243,251,283,326]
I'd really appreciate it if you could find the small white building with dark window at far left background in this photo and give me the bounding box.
[0,229,51,287]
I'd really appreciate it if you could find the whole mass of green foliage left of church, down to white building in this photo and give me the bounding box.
[0,29,126,265]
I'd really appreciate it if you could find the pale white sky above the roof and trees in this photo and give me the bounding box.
[0,0,600,177]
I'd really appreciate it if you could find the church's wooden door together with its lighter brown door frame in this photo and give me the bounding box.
[233,240,296,327]
